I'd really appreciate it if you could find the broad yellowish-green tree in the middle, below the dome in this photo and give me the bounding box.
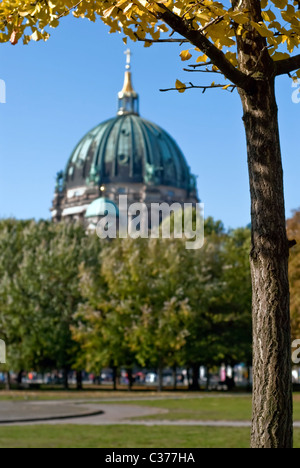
[74,239,188,389]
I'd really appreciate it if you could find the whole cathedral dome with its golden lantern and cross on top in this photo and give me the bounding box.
[51,51,198,222]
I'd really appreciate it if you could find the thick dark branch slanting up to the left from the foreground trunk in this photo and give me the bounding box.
[157,3,255,90]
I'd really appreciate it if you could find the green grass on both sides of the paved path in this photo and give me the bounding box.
[0,394,300,448]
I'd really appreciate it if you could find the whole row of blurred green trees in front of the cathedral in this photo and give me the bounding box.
[0,219,255,392]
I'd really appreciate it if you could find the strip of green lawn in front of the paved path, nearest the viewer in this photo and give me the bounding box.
[0,425,300,448]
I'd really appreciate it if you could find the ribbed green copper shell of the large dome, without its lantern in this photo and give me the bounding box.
[64,113,192,190]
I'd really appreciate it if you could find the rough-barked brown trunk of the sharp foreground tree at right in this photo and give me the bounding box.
[239,78,293,448]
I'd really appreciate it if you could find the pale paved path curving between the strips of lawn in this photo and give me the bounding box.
[0,400,300,428]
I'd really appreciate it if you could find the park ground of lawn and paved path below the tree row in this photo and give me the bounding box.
[0,391,300,448]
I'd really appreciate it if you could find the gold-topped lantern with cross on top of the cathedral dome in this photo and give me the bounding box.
[118,49,139,115]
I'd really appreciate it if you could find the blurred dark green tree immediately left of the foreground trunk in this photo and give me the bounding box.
[179,219,252,389]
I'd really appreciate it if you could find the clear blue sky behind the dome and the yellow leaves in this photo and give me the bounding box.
[0,17,300,227]
